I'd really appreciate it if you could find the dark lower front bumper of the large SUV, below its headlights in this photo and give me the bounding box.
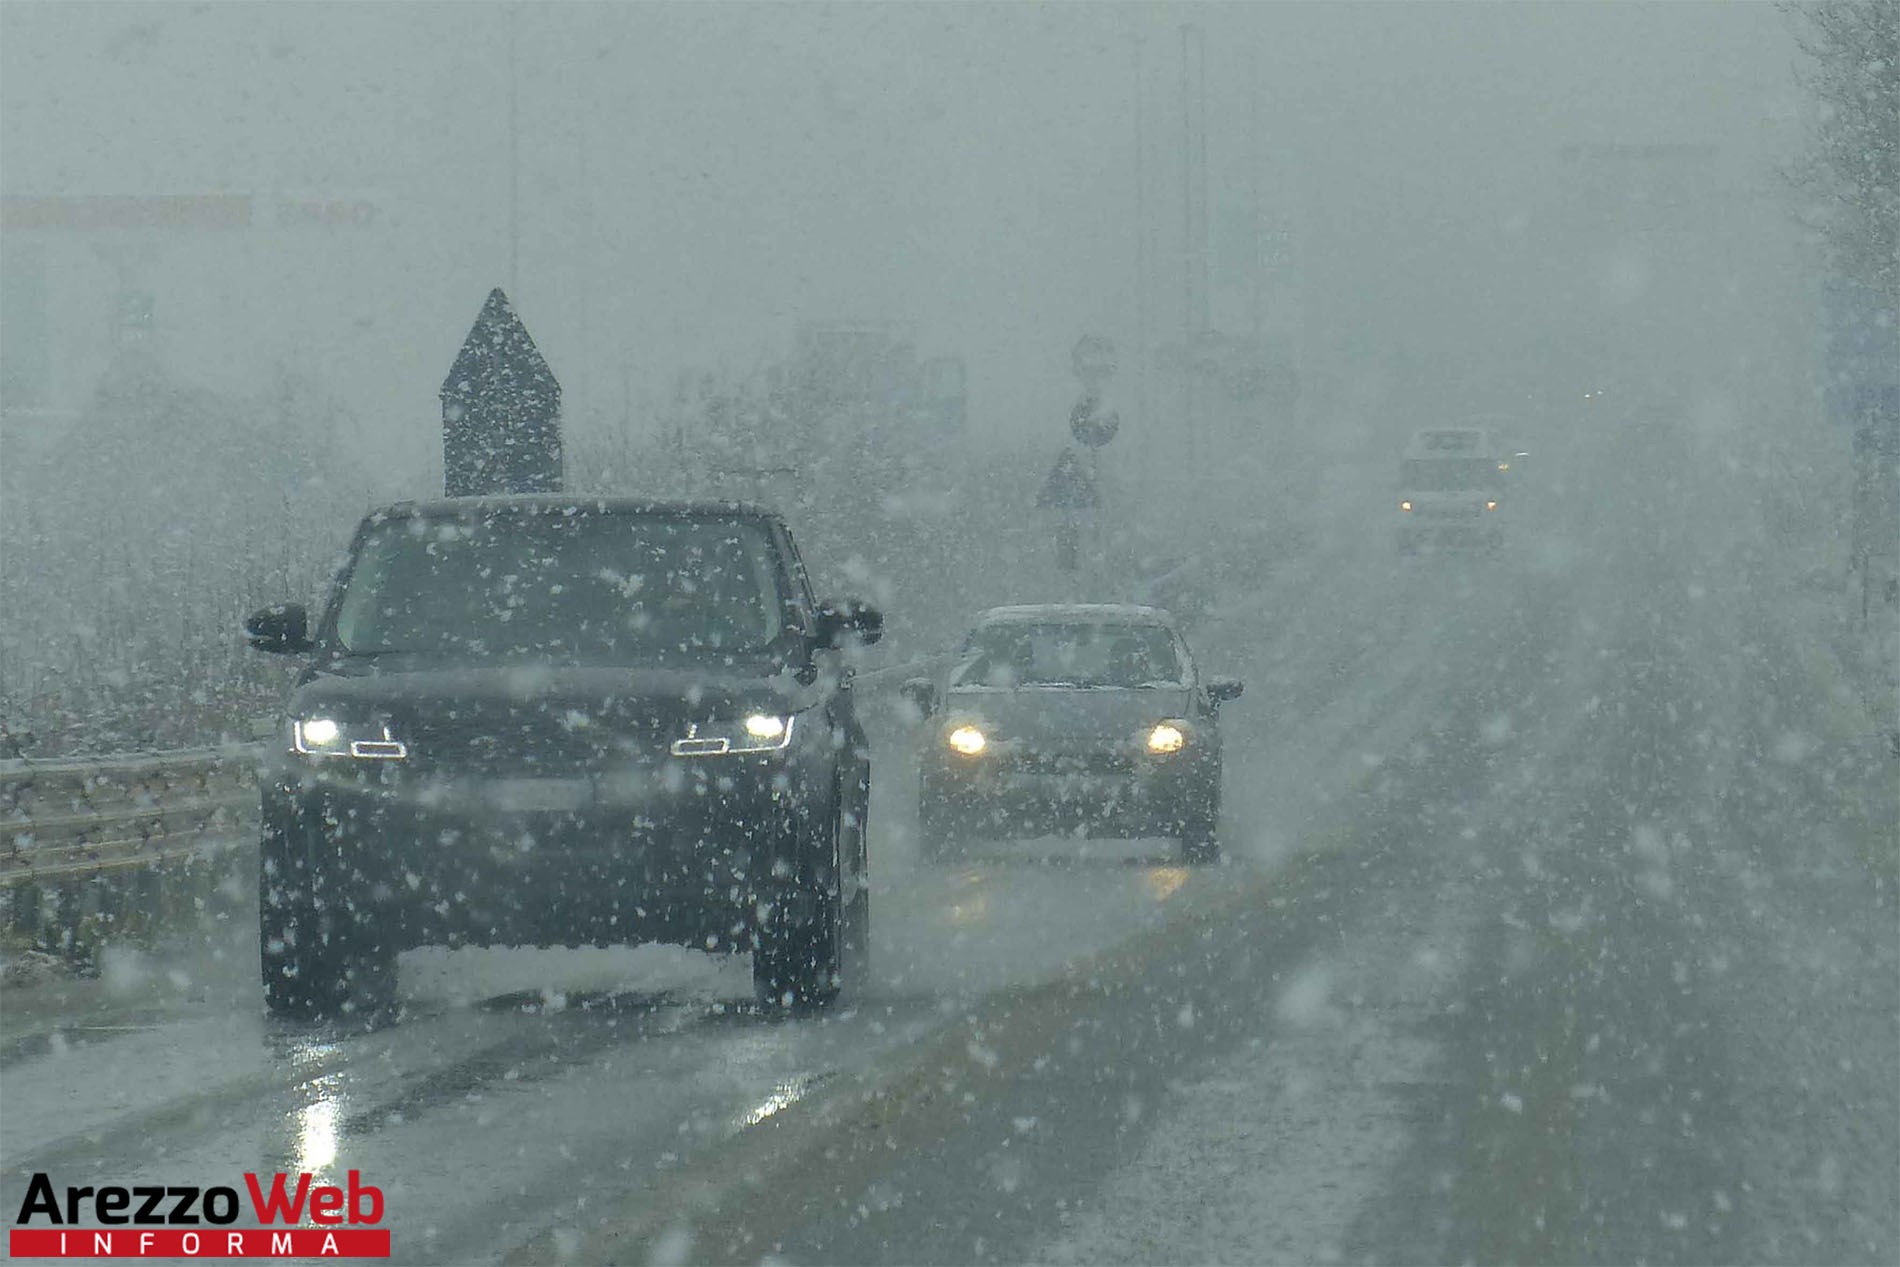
[262,758,830,950]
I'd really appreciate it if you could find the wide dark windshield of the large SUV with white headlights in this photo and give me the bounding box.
[336,513,781,665]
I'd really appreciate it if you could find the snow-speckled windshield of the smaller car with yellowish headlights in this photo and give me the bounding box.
[950,621,1184,690]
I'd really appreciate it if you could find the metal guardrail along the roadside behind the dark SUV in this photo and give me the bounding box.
[0,655,942,889]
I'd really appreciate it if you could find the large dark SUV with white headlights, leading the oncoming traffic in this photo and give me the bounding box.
[245,496,882,1014]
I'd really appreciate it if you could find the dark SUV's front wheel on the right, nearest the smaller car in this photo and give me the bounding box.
[752,819,847,1014]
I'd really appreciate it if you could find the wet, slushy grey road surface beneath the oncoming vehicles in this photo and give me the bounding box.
[0,431,1900,1263]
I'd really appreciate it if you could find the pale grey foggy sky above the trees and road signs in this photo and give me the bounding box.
[0,2,1799,478]
